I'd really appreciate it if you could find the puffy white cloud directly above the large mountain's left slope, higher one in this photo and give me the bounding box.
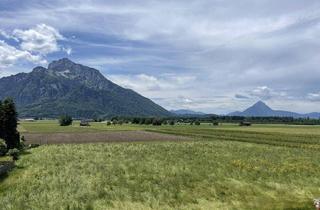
[13,24,64,55]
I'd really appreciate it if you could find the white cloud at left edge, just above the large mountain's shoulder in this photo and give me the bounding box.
[0,40,46,67]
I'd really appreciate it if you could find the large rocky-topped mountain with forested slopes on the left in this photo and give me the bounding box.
[0,58,171,118]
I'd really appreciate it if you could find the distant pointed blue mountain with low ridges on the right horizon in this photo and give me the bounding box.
[228,101,320,118]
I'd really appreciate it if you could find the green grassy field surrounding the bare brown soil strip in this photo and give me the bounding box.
[0,121,320,209]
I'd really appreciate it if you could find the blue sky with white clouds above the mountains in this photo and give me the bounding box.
[0,0,320,114]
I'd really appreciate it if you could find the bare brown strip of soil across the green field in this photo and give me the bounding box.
[23,131,190,144]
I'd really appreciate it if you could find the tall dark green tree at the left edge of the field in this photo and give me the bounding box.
[0,98,20,149]
